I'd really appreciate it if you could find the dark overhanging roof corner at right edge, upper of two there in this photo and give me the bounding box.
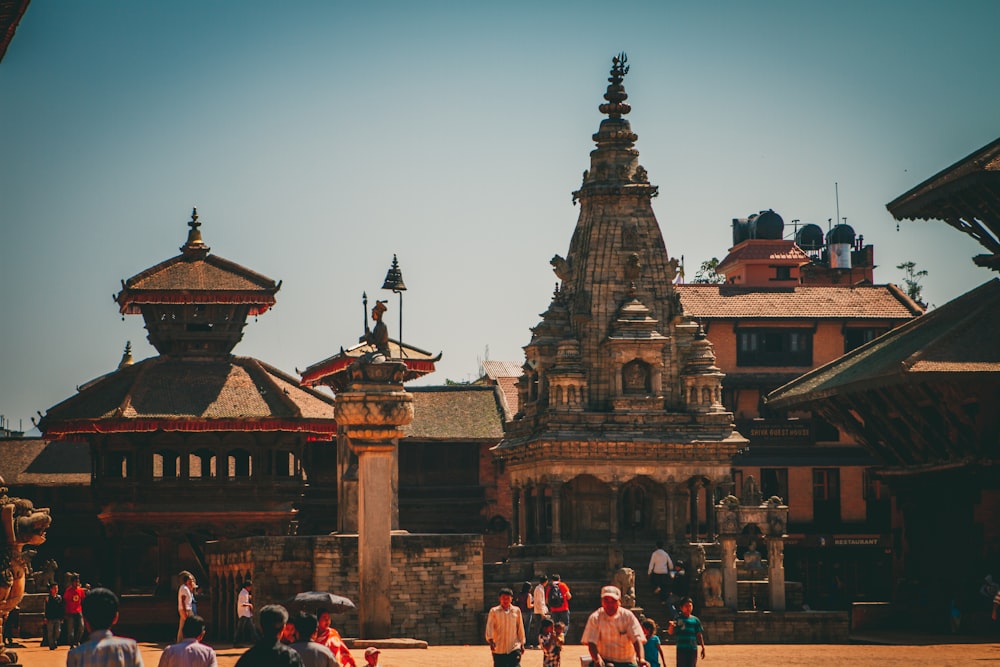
[886,139,1000,271]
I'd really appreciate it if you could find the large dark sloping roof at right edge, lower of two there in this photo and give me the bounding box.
[767,279,1000,409]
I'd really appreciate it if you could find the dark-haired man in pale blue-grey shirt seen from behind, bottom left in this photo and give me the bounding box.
[66,588,143,667]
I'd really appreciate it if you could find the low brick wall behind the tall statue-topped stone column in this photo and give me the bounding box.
[206,534,483,644]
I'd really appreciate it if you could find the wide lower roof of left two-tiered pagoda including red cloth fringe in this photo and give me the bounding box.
[38,356,336,438]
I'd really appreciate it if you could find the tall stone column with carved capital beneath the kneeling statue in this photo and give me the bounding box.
[334,360,413,639]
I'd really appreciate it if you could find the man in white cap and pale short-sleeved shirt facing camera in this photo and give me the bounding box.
[583,586,649,667]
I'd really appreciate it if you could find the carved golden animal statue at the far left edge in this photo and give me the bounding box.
[0,486,52,665]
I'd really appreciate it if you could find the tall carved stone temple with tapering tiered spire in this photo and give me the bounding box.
[495,54,746,553]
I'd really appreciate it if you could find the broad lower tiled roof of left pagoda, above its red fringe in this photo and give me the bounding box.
[41,357,333,433]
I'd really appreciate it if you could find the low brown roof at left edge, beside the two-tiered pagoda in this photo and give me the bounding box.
[0,438,90,487]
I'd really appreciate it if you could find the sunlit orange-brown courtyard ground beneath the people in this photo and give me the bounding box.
[9,640,1000,667]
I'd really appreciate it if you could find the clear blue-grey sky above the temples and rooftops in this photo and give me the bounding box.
[0,0,1000,430]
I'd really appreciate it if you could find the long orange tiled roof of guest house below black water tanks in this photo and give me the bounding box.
[677,284,922,320]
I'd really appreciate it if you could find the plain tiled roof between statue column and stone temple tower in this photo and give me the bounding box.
[406,385,503,442]
